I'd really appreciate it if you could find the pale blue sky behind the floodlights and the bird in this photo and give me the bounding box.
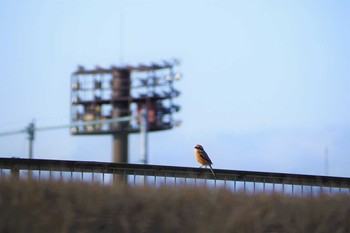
[0,0,350,176]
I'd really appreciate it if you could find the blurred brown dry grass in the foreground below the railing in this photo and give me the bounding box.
[0,177,350,233]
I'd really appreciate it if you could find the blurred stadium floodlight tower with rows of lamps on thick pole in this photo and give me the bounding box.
[71,60,181,163]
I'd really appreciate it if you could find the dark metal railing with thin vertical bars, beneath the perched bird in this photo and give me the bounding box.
[0,158,350,196]
